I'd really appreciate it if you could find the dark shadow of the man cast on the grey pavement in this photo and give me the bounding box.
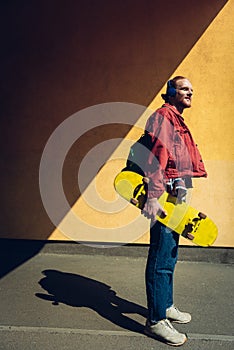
[35,270,147,333]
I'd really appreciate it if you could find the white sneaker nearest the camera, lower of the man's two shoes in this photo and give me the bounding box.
[145,320,187,346]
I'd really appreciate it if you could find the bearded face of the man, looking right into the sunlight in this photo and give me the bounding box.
[174,79,193,109]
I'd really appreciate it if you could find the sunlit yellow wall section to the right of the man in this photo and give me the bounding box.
[145,1,234,246]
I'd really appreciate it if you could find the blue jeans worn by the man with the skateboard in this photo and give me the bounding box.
[145,221,179,323]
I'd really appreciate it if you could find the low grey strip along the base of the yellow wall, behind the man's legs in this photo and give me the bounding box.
[0,239,234,264]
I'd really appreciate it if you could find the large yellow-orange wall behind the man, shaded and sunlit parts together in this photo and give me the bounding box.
[0,0,234,246]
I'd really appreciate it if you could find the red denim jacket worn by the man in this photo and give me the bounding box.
[145,103,207,198]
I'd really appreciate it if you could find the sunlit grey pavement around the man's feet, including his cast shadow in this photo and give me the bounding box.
[0,246,234,350]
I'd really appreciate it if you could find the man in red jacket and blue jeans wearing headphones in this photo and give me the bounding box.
[142,76,207,346]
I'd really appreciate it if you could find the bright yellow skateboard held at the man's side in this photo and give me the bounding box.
[114,171,218,247]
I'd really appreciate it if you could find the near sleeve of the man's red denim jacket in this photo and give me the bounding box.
[145,109,174,198]
